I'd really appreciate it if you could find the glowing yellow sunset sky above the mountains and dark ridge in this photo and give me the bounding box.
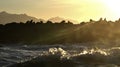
[0,0,120,21]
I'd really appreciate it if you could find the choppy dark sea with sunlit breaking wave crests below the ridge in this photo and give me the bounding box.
[0,44,120,67]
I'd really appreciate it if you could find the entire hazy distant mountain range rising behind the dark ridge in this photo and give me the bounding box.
[0,11,78,24]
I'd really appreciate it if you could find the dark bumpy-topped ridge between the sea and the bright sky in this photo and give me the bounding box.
[0,18,120,44]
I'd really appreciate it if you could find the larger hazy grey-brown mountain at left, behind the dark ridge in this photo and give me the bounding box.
[0,11,44,24]
